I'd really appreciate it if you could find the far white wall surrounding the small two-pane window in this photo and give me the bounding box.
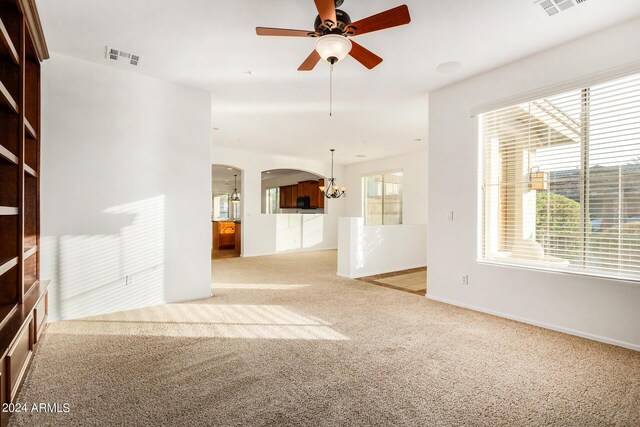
[344,153,427,229]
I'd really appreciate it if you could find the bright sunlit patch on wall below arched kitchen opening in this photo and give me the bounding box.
[274,214,324,253]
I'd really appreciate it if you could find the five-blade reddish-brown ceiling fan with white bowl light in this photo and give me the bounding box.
[256,0,411,71]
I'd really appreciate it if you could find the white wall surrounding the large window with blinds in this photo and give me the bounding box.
[427,20,640,350]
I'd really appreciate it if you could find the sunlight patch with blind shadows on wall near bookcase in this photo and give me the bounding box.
[41,195,165,321]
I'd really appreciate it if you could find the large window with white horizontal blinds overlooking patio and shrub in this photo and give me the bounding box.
[479,75,640,280]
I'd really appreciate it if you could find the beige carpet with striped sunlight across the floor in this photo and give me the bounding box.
[11,251,640,426]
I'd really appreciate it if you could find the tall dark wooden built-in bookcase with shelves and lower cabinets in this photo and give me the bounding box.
[0,0,49,425]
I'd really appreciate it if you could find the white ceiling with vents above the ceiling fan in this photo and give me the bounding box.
[37,0,640,163]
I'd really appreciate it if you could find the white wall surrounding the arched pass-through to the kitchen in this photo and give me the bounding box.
[211,146,350,257]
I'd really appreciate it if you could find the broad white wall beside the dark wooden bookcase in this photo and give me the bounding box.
[41,54,211,320]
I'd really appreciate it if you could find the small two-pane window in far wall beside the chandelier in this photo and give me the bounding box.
[362,171,403,225]
